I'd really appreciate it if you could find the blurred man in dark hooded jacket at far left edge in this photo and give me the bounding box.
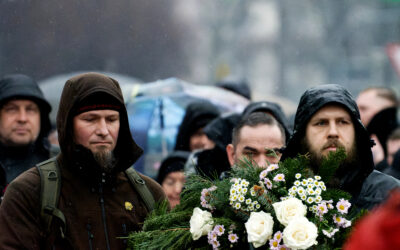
[0,74,51,183]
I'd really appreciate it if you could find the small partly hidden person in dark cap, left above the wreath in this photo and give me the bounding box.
[157,151,190,208]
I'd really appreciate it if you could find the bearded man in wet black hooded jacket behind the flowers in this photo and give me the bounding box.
[281,84,400,209]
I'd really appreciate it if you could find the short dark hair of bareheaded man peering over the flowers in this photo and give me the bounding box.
[232,112,286,147]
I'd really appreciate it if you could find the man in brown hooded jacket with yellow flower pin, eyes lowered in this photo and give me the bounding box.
[0,73,166,249]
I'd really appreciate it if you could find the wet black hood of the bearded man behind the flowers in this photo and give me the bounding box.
[281,84,374,194]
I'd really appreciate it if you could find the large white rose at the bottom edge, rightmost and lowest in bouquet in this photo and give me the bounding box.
[283,217,318,249]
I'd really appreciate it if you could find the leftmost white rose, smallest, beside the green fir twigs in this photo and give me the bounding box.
[190,207,213,240]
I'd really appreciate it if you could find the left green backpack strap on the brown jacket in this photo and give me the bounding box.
[36,157,66,238]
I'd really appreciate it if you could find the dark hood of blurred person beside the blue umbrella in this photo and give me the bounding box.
[174,101,220,151]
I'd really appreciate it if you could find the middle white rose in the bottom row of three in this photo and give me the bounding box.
[244,211,274,248]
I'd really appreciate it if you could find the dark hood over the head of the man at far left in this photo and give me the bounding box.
[0,74,51,146]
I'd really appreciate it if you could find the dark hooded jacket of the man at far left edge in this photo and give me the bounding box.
[0,74,51,182]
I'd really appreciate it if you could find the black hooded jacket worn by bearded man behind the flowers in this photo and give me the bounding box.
[281,84,400,209]
